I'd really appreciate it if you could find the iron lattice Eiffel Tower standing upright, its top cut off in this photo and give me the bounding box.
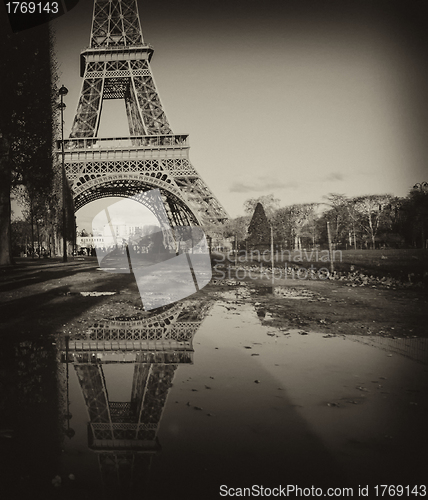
[63,0,228,226]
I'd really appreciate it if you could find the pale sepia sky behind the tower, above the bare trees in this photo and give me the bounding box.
[48,0,428,230]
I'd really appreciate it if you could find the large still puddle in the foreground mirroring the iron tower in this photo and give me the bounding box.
[0,290,428,500]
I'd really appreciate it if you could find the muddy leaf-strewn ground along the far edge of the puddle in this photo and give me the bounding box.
[0,257,428,337]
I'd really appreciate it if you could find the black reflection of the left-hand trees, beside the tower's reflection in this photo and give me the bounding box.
[0,332,61,499]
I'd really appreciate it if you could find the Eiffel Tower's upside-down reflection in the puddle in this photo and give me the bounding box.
[61,301,211,498]
